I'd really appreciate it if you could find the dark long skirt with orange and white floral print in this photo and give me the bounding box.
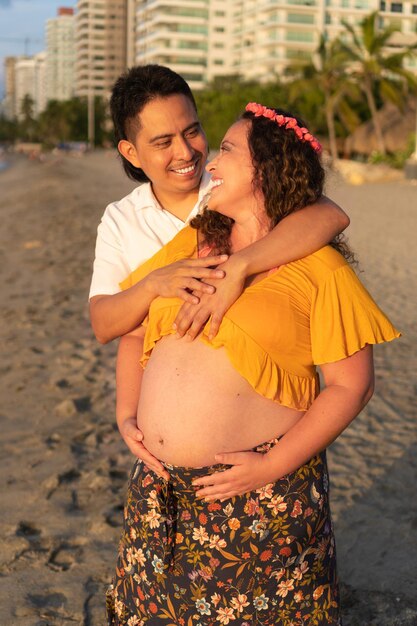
[107,440,341,626]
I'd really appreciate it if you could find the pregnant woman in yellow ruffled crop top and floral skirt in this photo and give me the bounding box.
[108,103,399,626]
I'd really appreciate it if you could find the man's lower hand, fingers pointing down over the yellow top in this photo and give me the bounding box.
[174,256,246,339]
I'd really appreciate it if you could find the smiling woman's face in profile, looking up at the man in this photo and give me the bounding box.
[206,120,263,223]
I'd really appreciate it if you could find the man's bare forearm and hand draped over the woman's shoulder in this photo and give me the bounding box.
[175,197,349,339]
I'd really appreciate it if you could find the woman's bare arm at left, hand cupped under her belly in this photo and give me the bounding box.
[116,326,169,478]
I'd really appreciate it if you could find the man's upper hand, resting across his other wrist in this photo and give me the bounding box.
[146,254,228,304]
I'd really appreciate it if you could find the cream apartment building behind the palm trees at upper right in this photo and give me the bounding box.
[232,0,417,81]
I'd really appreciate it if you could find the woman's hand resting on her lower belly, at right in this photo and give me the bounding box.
[193,452,276,501]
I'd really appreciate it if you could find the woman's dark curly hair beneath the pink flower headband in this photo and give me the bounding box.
[191,109,353,260]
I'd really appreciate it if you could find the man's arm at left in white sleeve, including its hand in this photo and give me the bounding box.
[90,198,225,343]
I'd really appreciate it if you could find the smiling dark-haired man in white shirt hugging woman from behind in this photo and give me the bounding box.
[90,65,349,473]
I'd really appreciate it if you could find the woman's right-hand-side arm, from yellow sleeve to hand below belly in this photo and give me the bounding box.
[190,346,374,500]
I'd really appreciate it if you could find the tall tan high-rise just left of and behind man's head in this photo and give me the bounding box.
[75,0,131,96]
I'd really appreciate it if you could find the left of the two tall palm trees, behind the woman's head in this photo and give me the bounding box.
[290,35,359,161]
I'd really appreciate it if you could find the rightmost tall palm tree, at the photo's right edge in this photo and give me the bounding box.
[340,11,417,154]
